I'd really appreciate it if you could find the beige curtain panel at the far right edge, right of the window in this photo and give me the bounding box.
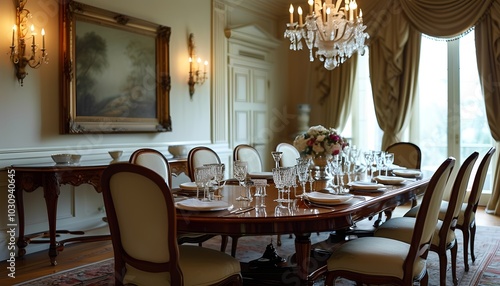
[475,1,500,215]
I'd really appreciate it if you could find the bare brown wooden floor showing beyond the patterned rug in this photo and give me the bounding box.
[0,207,500,285]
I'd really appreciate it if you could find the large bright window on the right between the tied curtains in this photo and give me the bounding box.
[410,31,494,192]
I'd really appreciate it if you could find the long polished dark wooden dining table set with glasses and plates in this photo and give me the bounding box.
[173,175,430,285]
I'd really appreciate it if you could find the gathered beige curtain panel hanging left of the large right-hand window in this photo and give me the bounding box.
[367,2,420,150]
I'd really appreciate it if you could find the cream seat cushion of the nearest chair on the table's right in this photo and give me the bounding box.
[327,237,426,279]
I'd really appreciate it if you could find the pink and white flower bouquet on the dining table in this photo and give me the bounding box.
[293,125,348,158]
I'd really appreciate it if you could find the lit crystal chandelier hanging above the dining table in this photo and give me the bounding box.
[285,0,369,70]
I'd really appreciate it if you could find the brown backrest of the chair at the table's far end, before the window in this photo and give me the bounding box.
[385,142,422,169]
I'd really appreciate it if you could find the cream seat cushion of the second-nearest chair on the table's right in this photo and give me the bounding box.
[374,217,455,246]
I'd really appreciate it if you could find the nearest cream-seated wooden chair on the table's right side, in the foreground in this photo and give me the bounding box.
[326,157,455,286]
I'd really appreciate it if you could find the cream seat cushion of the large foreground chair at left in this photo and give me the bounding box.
[123,245,241,285]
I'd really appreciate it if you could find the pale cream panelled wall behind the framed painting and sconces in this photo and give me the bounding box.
[0,0,217,260]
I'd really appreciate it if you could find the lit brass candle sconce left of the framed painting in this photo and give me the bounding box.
[10,0,48,86]
